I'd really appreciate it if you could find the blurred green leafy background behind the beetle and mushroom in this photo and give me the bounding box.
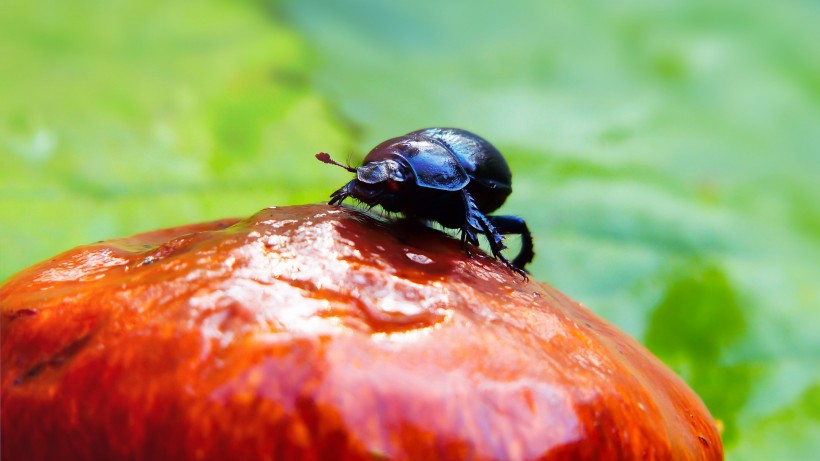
[0,0,820,460]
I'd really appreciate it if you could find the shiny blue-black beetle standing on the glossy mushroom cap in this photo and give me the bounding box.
[316,128,535,274]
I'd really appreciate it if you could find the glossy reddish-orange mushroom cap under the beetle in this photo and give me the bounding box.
[0,205,722,460]
